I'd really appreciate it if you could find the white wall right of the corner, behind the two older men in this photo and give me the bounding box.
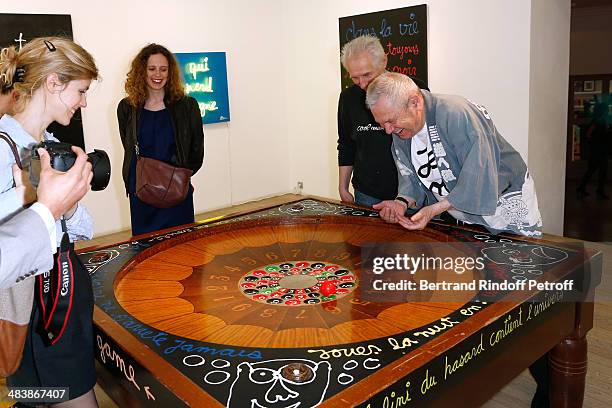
[284,0,530,197]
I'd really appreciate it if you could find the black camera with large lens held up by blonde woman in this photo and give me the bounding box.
[30,140,110,191]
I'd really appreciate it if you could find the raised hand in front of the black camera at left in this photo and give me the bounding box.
[38,146,93,220]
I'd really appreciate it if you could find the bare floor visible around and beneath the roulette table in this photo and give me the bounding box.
[0,194,612,408]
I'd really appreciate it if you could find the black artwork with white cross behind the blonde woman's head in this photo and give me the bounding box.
[0,13,85,149]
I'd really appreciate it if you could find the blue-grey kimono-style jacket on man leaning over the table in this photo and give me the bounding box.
[392,90,542,236]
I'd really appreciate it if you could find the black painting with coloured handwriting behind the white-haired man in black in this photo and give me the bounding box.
[339,4,428,89]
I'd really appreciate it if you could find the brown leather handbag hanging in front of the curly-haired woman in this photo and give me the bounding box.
[136,144,193,208]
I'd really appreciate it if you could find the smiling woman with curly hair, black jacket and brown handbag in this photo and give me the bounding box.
[117,44,204,235]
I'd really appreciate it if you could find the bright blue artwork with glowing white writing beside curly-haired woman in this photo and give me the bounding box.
[174,52,230,124]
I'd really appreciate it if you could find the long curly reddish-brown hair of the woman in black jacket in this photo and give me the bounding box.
[125,44,185,107]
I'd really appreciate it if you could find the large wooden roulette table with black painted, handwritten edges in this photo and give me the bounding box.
[79,197,601,408]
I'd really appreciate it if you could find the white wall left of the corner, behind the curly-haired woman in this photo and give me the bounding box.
[2,0,289,235]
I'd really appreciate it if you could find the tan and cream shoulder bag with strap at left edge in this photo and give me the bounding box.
[0,132,34,377]
